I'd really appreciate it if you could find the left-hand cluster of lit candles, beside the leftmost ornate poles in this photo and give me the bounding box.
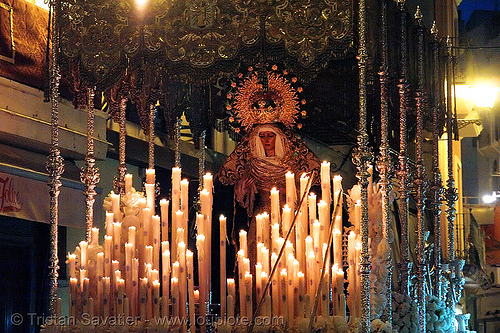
[68,168,213,330]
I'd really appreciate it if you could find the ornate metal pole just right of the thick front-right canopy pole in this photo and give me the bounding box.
[377,0,393,325]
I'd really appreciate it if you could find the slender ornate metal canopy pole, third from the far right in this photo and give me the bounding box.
[414,6,426,332]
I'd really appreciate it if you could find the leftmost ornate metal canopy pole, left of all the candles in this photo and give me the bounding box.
[46,0,64,316]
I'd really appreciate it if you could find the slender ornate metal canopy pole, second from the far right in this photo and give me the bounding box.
[431,22,443,299]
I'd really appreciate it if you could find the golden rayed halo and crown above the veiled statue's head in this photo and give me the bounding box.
[232,72,300,130]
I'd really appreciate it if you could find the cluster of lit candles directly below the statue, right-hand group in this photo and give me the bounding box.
[229,162,361,325]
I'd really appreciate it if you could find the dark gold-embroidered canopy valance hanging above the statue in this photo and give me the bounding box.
[60,0,353,87]
